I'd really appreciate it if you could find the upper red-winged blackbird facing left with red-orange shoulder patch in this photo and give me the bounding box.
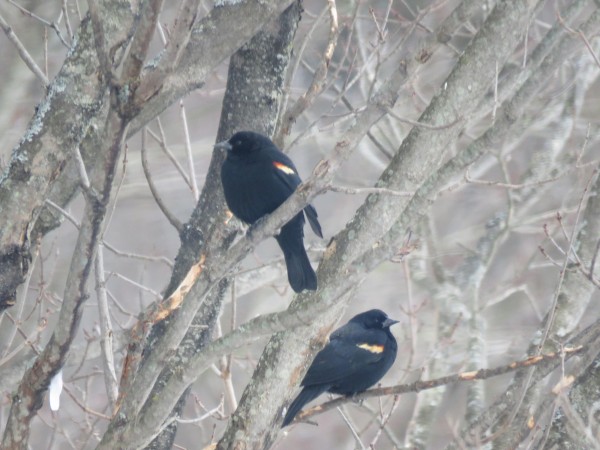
[215,131,323,292]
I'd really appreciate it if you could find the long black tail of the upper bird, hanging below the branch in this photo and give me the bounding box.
[275,213,317,292]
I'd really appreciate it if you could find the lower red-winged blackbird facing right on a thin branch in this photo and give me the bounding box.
[281,309,398,428]
